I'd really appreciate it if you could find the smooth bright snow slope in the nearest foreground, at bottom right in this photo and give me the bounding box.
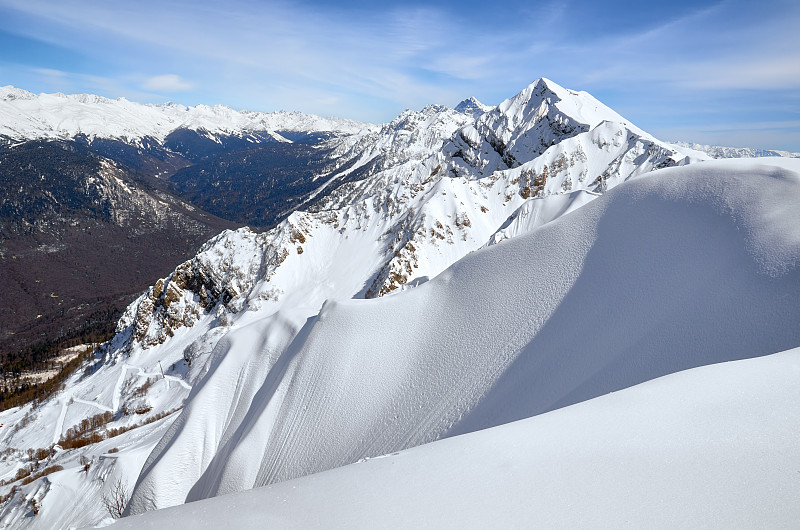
[103,349,800,530]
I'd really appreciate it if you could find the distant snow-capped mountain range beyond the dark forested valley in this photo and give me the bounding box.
[0,86,366,143]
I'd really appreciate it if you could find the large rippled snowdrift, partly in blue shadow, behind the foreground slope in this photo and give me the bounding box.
[120,159,800,524]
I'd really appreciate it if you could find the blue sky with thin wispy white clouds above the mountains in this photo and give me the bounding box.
[0,0,800,148]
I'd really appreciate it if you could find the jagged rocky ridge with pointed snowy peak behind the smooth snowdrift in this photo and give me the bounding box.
[122,81,703,350]
